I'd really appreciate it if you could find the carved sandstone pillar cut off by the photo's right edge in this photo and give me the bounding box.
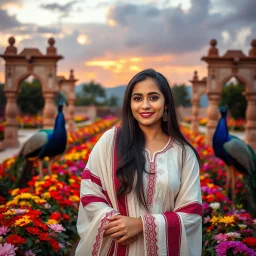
[245,92,256,150]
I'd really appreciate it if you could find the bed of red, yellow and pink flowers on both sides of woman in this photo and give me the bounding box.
[0,123,256,256]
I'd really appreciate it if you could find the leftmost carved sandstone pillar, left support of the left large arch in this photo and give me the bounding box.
[3,91,19,148]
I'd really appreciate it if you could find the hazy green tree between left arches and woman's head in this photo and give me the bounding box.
[76,81,106,106]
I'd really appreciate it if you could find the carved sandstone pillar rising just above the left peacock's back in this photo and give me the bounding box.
[43,91,56,129]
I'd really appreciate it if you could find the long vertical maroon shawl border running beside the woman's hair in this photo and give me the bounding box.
[113,127,129,256]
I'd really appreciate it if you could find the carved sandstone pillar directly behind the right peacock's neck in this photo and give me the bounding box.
[206,93,221,146]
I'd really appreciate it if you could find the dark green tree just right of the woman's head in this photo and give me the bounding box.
[171,84,191,107]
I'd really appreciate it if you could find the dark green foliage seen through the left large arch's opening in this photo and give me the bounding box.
[17,80,44,115]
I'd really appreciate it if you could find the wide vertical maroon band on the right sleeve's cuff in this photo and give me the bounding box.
[163,212,181,256]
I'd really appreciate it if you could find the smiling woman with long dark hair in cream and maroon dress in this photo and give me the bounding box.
[76,69,202,256]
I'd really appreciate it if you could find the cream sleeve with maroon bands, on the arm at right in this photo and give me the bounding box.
[141,148,202,256]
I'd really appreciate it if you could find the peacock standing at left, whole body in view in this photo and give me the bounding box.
[17,100,67,187]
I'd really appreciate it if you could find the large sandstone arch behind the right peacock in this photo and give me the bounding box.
[191,39,256,150]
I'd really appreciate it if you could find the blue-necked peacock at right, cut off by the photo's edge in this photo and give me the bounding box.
[212,106,256,214]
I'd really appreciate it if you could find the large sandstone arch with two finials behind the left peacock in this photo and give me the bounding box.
[0,37,63,148]
